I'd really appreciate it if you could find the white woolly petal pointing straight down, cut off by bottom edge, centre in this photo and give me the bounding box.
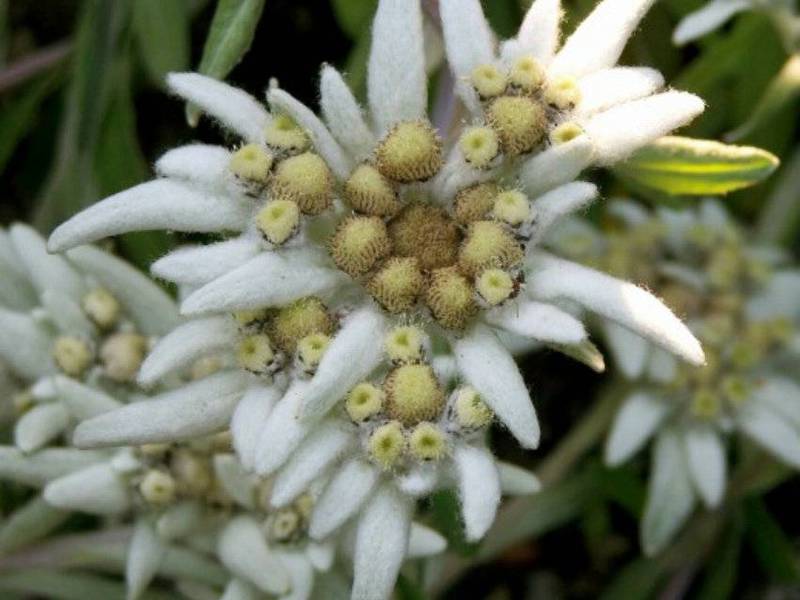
[351,484,412,600]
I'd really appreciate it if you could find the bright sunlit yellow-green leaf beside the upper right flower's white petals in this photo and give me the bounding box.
[615,136,779,196]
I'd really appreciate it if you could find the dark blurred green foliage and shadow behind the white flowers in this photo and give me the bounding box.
[0,0,800,600]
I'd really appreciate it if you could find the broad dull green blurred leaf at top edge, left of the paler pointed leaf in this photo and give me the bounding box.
[133,0,190,86]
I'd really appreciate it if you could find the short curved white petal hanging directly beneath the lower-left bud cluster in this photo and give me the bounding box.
[231,384,283,471]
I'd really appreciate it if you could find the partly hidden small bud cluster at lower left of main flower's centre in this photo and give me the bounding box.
[234,296,336,376]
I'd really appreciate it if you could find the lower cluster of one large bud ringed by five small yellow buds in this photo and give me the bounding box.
[345,326,492,471]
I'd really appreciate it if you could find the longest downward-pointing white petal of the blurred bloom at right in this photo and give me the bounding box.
[641,430,696,556]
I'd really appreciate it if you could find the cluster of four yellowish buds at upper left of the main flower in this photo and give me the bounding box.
[229,115,334,246]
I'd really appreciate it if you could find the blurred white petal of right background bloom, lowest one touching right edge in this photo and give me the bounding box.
[736,401,800,469]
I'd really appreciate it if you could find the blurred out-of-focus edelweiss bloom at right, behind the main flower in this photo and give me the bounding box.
[558,200,800,554]
